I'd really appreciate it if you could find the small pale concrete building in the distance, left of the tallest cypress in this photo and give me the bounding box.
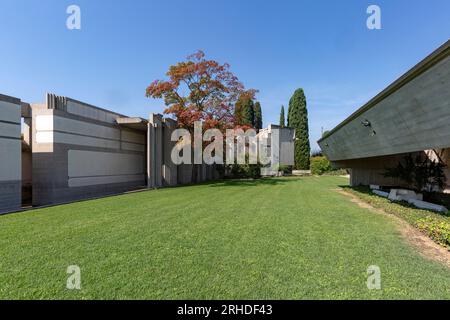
[258,124,295,176]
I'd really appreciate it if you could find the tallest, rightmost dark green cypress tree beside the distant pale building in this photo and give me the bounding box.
[288,89,311,170]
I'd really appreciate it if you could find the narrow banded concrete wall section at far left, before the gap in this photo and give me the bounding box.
[0,94,22,213]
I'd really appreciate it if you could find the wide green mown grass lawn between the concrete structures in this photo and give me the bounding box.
[0,177,450,299]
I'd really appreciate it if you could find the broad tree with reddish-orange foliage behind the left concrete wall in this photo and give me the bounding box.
[146,51,257,181]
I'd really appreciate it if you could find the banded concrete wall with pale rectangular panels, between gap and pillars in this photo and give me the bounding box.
[32,95,146,205]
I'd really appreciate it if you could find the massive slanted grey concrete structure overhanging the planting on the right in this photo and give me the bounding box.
[318,41,450,187]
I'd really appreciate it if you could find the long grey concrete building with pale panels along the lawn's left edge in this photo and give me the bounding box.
[0,94,219,213]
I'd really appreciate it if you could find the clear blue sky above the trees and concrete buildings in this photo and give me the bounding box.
[0,0,450,149]
